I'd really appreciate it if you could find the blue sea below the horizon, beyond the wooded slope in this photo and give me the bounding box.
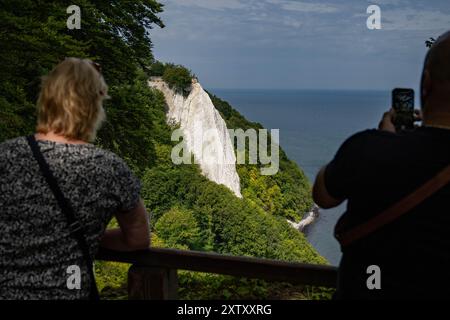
[210,89,396,265]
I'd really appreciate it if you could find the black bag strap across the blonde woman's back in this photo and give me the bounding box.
[27,135,99,300]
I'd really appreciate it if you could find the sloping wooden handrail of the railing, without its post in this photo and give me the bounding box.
[96,248,337,288]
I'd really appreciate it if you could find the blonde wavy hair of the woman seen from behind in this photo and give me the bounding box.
[36,58,109,142]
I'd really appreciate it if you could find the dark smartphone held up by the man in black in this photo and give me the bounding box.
[392,88,414,131]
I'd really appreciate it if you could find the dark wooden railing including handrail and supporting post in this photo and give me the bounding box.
[97,248,337,300]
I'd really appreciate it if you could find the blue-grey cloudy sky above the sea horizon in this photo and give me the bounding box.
[151,0,450,90]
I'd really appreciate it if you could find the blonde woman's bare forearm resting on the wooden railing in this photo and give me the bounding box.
[100,200,150,251]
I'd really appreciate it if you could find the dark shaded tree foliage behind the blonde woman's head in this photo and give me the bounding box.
[0,0,163,169]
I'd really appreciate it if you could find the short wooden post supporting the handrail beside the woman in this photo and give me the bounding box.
[128,265,178,300]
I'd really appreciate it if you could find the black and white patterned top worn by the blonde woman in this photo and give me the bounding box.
[0,137,141,299]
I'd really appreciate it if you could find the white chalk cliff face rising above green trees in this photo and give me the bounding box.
[149,78,242,198]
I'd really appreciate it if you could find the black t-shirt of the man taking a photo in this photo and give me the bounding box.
[325,127,450,299]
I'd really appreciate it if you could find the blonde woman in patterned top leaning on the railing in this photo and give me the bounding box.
[0,58,149,299]
